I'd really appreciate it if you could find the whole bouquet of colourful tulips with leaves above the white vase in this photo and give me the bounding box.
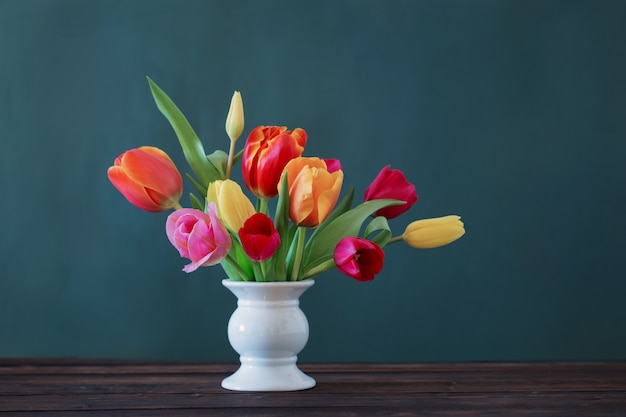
[108,78,465,281]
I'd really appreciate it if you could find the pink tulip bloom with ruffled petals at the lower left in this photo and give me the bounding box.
[165,203,232,272]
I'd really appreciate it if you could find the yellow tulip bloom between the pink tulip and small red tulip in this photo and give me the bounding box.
[206,180,256,232]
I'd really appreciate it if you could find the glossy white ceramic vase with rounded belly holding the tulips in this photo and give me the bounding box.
[222,279,315,391]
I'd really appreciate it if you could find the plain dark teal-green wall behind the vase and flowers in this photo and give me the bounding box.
[0,0,626,361]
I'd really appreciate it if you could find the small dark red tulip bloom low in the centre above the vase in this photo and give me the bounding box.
[239,213,280,262]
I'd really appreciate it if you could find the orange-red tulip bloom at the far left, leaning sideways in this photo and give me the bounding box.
[107,146,183,212]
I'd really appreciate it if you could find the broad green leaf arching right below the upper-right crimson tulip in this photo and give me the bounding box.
[301,199,404,275]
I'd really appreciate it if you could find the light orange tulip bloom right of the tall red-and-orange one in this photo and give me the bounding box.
[283,157,343,227]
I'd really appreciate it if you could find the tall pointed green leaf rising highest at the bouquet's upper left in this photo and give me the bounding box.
[146,77,223,188]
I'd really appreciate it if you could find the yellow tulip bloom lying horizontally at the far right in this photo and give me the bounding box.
[402,215,465,249]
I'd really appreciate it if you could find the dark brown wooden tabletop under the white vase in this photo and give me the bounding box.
[0,359,626,417]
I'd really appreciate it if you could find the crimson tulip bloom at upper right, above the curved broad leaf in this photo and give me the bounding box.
[364,165,417,219]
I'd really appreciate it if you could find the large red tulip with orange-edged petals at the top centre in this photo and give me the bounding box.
[241,126,307,199]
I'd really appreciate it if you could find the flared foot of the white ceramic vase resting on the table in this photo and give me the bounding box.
[222,357,315,391]
